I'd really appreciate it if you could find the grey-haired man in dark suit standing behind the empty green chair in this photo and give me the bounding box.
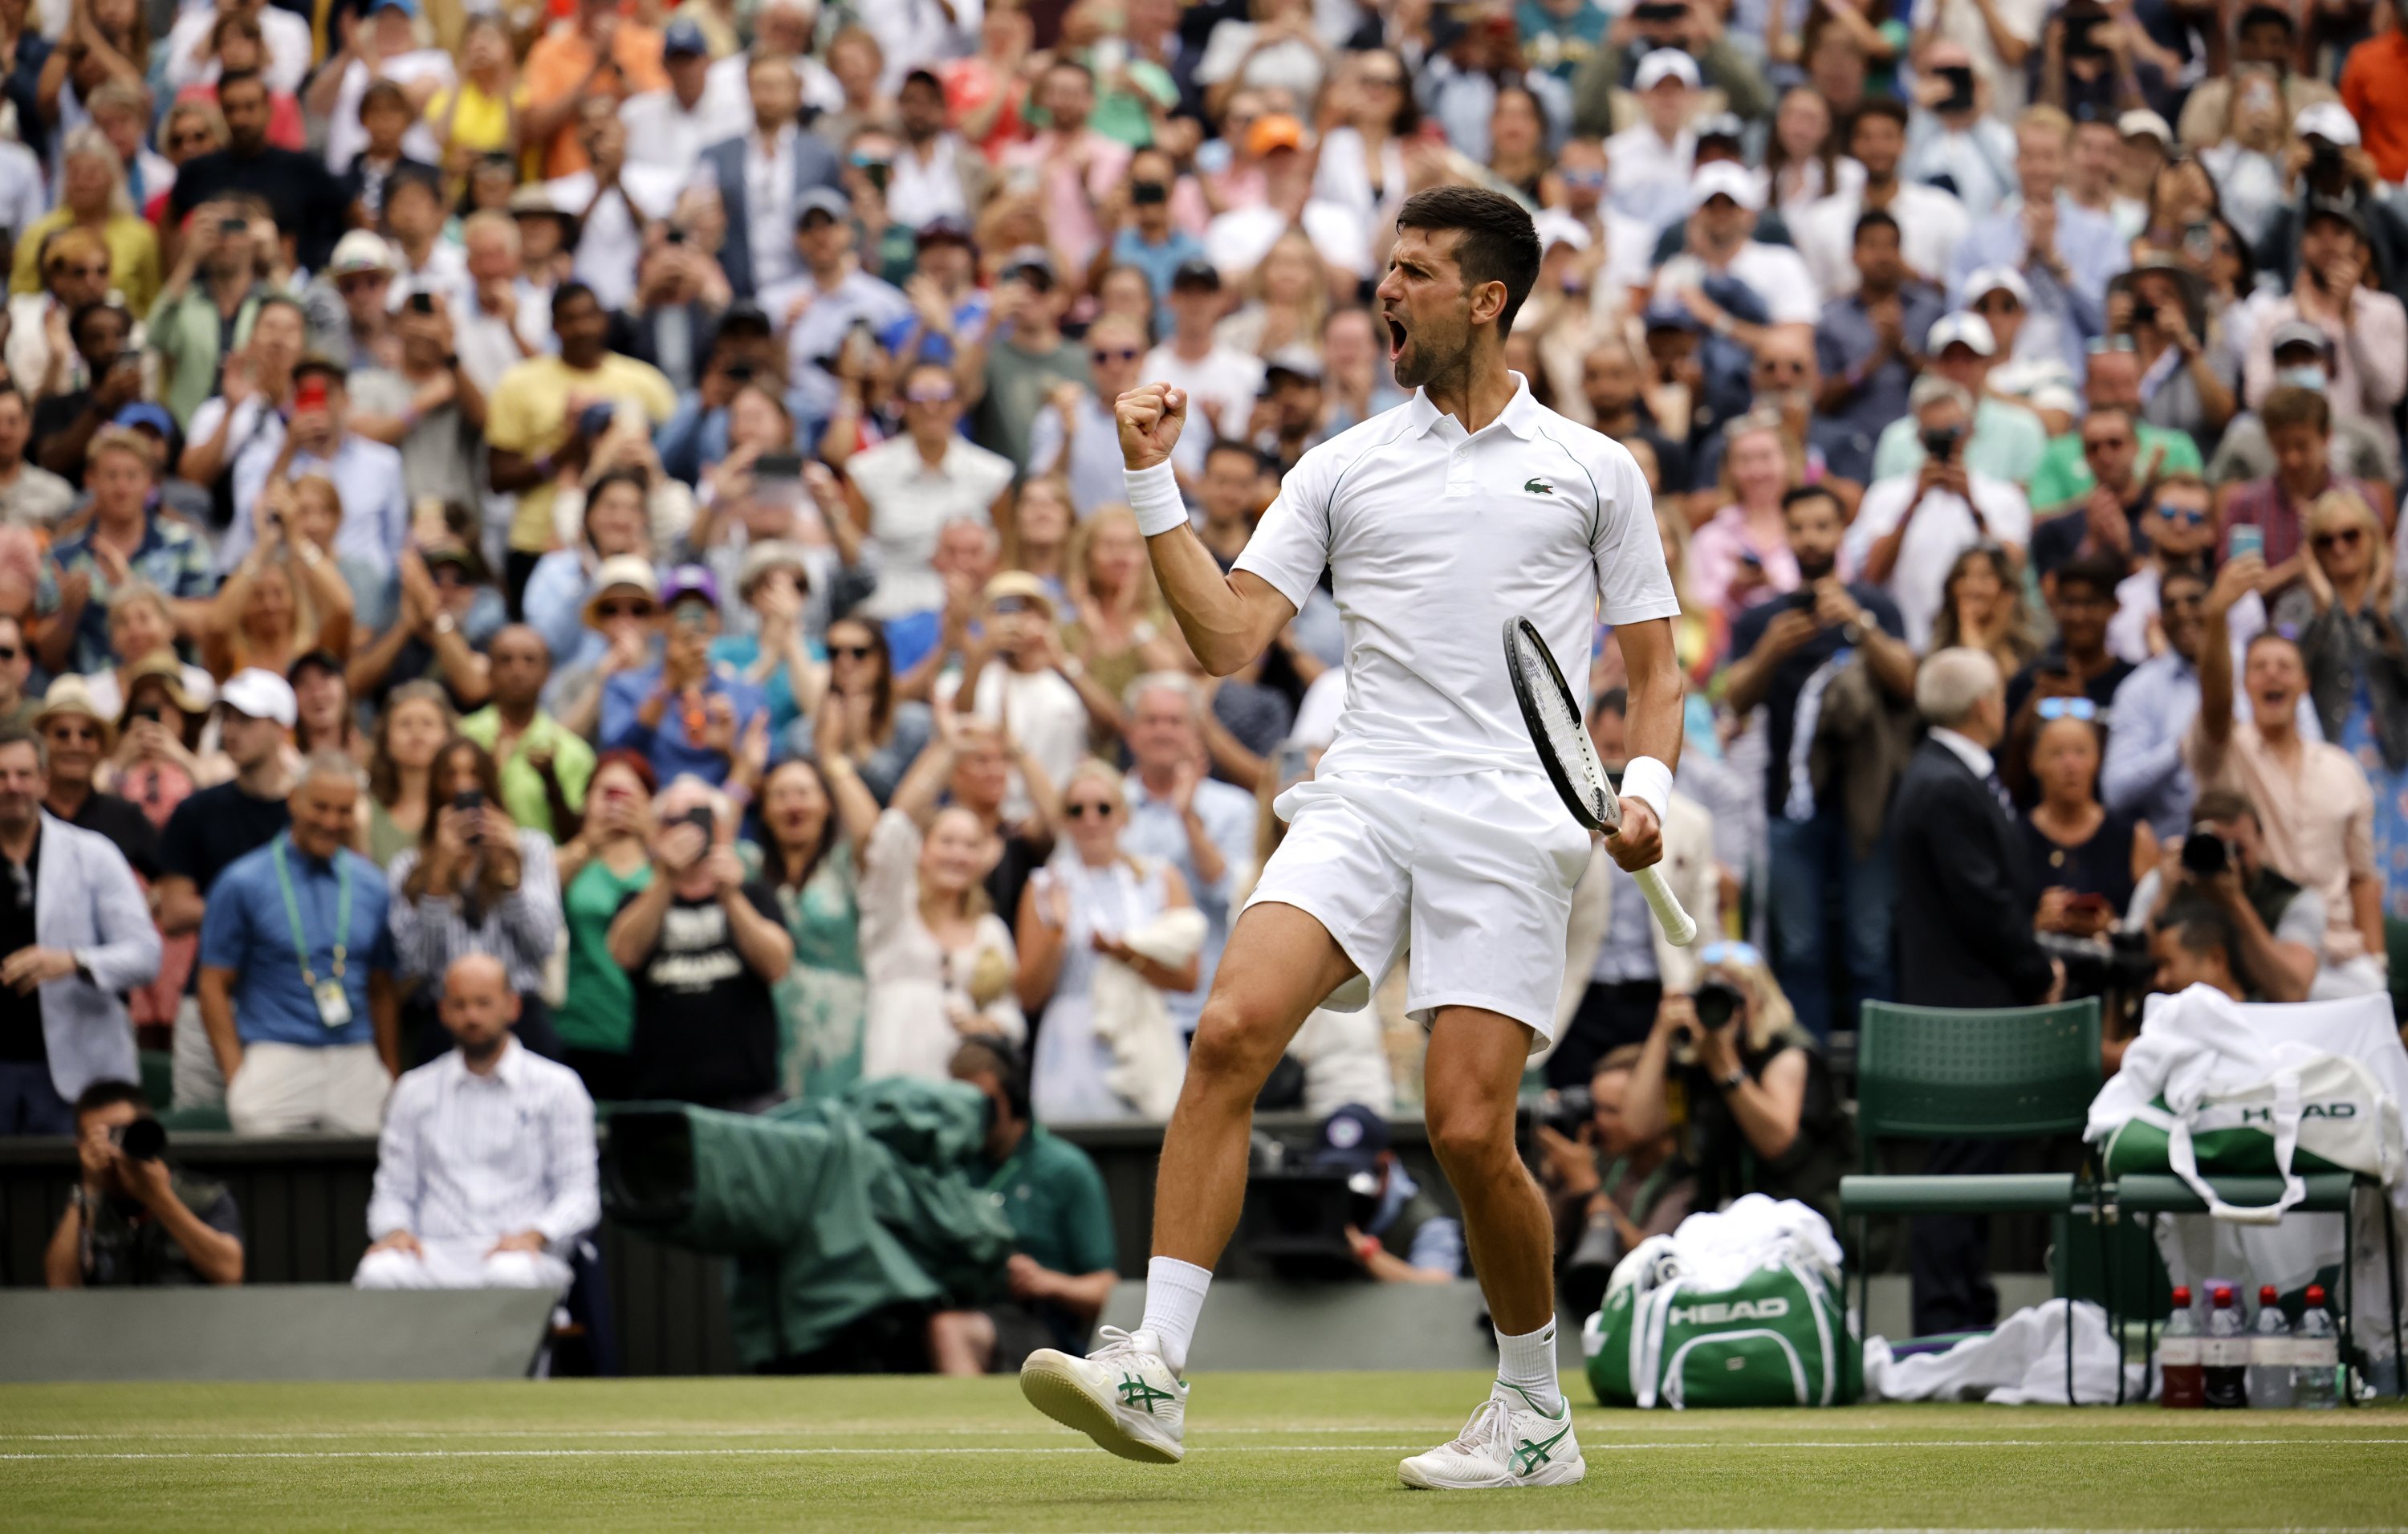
[1890,648,2064,1337]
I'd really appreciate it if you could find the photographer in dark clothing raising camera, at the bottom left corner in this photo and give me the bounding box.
[41,1081,243,1288]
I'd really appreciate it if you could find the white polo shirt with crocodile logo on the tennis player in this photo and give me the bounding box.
[1238,376,1681,778]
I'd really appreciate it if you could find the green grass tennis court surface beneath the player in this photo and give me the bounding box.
[0,1373,2408,1534]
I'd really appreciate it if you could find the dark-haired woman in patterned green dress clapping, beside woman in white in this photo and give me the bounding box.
[761,747,877,1098]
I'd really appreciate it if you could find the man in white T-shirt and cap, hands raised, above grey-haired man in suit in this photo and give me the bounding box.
[1840,373,2032,653]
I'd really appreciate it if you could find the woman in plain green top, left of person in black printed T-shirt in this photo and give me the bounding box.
[551,751,657,1103]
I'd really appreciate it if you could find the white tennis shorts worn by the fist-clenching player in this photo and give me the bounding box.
[1247,773,1589,1050]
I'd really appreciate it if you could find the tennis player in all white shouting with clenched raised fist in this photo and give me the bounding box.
[1021,188,1681,1488]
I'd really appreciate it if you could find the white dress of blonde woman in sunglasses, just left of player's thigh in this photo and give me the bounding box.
[1028,850,1170,1125]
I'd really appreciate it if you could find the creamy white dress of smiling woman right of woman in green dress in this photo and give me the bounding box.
[860,809,1028,1081]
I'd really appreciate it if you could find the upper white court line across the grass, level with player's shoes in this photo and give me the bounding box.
[0,1438,2408,1462]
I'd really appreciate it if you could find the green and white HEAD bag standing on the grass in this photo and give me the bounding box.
[1582,1259,1857,1411]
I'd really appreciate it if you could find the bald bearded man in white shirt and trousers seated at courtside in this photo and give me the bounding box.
[352,954,602,1291]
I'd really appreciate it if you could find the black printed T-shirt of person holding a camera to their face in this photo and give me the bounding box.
[619,879,783,1108]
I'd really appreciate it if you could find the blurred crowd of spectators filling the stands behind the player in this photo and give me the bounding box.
[0,0,2408,1339]
